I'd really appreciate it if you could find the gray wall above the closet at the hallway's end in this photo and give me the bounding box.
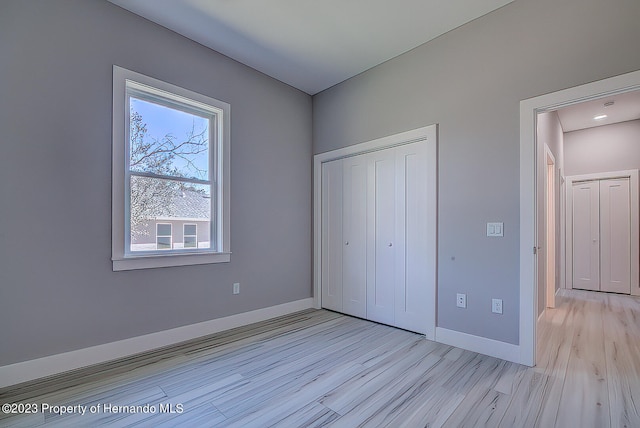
[564,120,640,175]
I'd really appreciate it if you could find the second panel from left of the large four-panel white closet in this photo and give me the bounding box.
[342,155,368,318]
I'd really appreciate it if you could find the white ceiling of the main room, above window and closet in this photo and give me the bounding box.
[109,0,513,95]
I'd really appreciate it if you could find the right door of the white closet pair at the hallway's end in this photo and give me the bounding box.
[600,178,631,294]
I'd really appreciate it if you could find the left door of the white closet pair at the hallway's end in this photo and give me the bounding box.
[573,181,600,290]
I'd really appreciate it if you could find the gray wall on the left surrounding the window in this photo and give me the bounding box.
[0,0,312,365]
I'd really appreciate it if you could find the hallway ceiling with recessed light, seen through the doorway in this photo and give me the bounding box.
[558,91,640,132]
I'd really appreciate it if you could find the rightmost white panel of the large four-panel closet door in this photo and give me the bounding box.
[394,143,429,333]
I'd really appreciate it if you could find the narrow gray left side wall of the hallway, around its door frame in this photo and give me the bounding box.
[536,111,564,315]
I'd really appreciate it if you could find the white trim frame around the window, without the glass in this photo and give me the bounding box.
[111,65,231,271]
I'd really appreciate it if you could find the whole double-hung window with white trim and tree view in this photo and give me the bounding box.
[112,66,230,270]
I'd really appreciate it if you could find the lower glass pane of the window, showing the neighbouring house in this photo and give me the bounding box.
[129,175,212,252]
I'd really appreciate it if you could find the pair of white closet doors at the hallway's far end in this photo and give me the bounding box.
[572,178,631,294]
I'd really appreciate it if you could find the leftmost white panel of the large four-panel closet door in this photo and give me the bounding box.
[322,160,344,312]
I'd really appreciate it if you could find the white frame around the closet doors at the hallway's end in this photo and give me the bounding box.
[565,169,640,296]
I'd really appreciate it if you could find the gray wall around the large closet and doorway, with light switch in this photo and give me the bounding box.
[313,0,640,344]
